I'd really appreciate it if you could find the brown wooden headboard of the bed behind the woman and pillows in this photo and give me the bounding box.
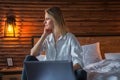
[32,35,120,59]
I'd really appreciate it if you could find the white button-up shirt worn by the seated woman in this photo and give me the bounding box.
[37,33,83,66]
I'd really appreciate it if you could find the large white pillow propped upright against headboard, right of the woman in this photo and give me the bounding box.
[82,42,102,67]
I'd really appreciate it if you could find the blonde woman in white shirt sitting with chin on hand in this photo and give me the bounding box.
[22,7,86,80]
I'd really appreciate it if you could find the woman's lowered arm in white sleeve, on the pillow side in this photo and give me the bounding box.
[71,35,83,70]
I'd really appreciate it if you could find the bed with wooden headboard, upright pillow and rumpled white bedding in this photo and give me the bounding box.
[32,35,120,80]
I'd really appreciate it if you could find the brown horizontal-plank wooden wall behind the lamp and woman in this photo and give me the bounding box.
[0,0,120,68]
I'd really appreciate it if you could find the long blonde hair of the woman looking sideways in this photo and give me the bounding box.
[45,7,68,35]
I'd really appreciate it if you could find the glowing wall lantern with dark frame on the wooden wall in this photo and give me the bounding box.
[4,15,16,37]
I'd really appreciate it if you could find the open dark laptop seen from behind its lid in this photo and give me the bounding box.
[24,61,76,80]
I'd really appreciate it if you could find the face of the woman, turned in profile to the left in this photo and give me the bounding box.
[44,13,54,30]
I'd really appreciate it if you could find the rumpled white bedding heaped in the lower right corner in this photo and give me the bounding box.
[84,59,120,80]
